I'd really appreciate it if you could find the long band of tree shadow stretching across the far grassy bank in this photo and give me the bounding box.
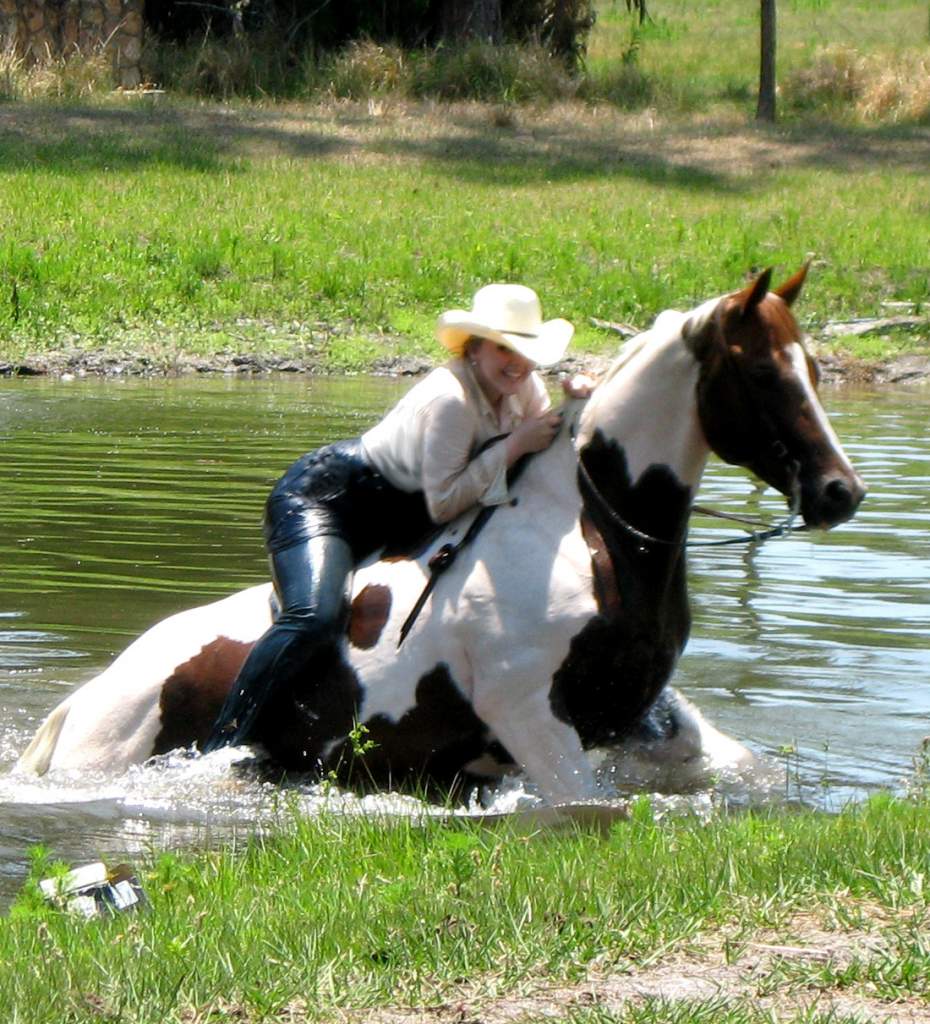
[0,101,930,185]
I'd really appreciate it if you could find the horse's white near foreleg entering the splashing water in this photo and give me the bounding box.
[472,674,596,804]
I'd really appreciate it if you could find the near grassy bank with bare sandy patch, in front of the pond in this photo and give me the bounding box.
[0,797,930,1024]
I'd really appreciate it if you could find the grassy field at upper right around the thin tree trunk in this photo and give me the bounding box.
[587,0,930,124]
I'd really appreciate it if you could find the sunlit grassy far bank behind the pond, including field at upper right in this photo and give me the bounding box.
[0,0,930,369]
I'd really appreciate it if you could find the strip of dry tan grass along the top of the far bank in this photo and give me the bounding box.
[0,95,930,179]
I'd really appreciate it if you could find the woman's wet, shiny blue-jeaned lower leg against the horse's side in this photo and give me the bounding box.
[203,536,354,754]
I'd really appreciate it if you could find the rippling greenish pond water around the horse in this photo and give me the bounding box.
[0,377,930,901]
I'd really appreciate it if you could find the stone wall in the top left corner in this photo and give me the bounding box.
[0,0,144,89]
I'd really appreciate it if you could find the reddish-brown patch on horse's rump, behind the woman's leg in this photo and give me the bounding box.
[152,637,254,754]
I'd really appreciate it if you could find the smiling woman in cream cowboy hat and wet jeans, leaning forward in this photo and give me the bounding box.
[204,285,591,752]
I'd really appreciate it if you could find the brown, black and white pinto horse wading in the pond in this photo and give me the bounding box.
[18,266,865,804]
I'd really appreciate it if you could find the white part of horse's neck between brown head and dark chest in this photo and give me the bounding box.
[578,311,709,493]
